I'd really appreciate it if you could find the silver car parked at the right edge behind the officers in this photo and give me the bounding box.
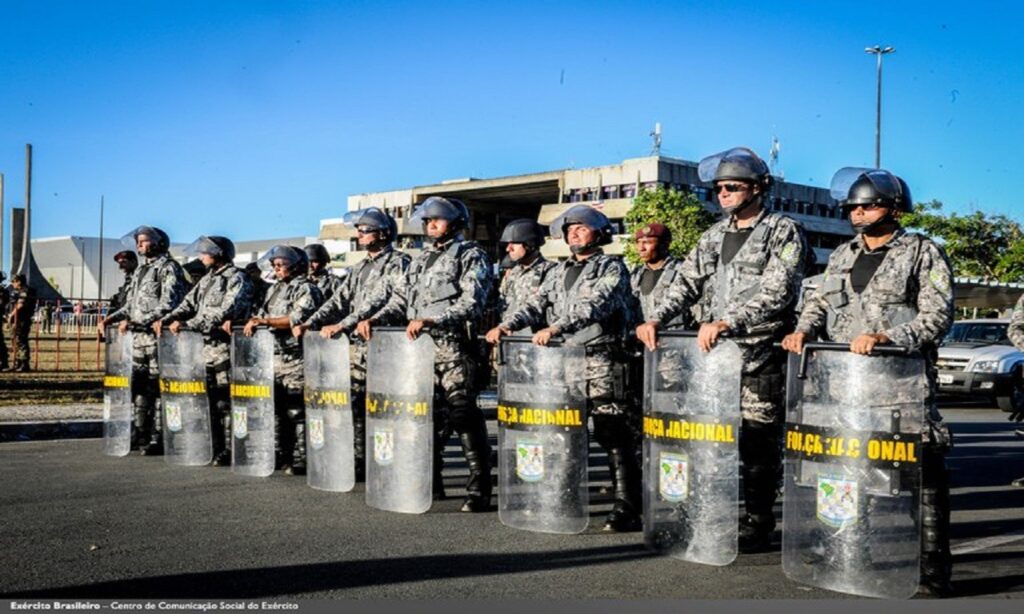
[938,319,1024,411]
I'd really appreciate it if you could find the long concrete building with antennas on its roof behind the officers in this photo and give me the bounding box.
[319,157,853,269]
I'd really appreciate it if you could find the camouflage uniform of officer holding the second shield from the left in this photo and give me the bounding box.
[163,264,253,456]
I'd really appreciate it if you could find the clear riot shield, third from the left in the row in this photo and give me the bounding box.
[231,328,274,478]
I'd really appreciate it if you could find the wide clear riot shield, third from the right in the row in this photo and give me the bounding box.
[498,337,590,534]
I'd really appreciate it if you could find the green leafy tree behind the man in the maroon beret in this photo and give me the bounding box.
[625,186,716,266]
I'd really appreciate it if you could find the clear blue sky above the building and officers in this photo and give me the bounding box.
[0,0,1024,245]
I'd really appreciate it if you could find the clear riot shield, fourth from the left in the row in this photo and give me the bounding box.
[302,332,355,492]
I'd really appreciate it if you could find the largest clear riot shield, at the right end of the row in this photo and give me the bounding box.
[782,344,928,599]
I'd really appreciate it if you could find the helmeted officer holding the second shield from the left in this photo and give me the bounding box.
[159,235,253,467]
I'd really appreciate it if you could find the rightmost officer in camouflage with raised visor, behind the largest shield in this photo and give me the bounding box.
[782,168,953,596]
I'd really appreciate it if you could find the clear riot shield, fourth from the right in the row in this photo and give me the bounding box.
[367,327,434,514]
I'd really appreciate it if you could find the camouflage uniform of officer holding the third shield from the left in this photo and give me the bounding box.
[256,274,324,467]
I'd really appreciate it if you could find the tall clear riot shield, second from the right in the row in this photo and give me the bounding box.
[643,333,743,565]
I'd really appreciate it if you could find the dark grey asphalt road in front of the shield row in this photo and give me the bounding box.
[0,406,1024,600]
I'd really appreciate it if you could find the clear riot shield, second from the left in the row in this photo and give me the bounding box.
[157,331,213,467]
